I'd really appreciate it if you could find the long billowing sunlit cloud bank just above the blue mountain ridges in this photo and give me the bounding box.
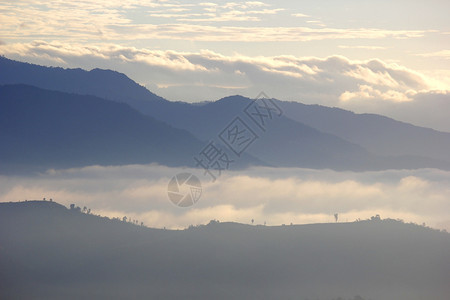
[0,41,428,91]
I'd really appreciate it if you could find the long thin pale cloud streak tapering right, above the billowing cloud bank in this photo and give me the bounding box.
[107,24,426,42]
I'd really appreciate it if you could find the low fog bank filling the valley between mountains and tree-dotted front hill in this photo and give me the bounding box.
[0,165,450,230]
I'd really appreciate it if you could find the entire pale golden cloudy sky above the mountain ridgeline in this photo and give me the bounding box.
[0,0,450,132]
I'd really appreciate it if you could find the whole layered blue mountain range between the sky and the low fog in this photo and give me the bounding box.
[0,57,450,173]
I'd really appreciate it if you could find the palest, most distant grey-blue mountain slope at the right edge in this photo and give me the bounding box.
[277,101,450,162]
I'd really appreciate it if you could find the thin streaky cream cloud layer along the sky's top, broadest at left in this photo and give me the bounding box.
[0,0,427,42]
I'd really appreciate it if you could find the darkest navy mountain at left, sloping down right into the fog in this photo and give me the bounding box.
[0,85,204,172]
